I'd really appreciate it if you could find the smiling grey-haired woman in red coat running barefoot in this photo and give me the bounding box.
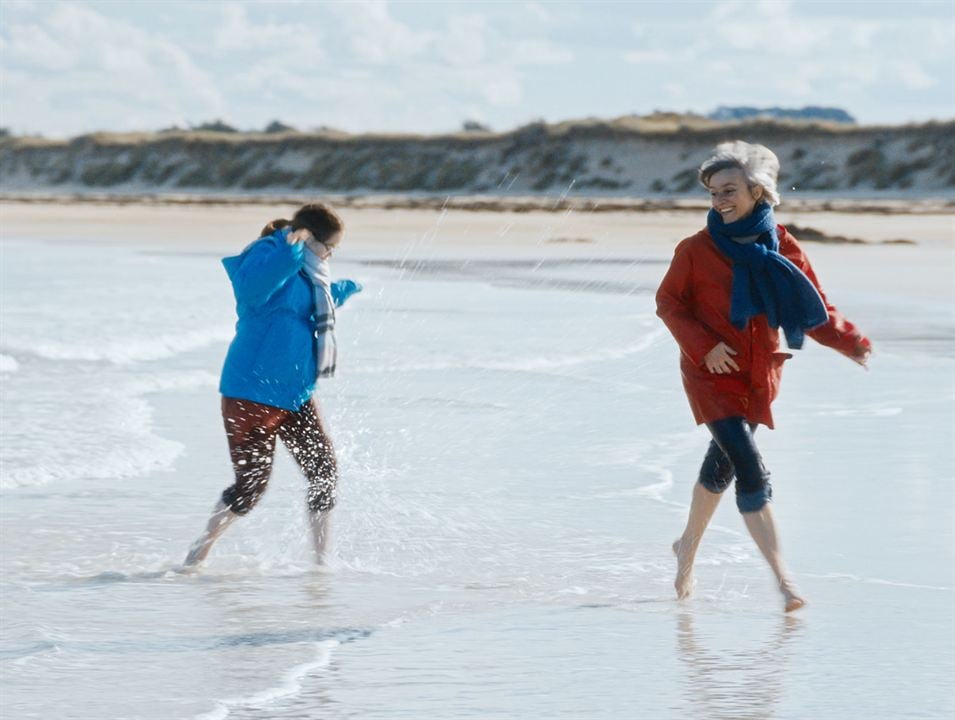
[656,141,871,612]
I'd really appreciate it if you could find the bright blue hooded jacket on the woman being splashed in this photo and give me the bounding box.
[219,228,361,411]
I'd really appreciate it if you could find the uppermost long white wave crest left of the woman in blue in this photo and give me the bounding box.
[4,325,233,365]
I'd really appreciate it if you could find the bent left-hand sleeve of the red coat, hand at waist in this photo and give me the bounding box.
[657,242,720,365]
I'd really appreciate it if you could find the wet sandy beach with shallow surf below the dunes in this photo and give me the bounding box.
[0,202,955,720]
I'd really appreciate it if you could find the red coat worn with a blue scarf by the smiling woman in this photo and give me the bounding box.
[657,225,868,428]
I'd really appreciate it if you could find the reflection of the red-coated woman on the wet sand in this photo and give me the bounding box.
[677,611,802,720]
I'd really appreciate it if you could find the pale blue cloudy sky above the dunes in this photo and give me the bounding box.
[0,0,955,137]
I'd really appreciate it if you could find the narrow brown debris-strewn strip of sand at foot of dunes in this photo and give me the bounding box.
[0,192,955,215]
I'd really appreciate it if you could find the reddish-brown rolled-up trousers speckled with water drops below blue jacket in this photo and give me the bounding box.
[222,397,338,515]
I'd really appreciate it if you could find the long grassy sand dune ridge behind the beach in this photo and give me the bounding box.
[0,113,955,198]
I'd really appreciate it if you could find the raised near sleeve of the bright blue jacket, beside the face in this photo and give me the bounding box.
[223,236,303,307]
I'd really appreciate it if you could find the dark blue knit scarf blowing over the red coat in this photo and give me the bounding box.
[706,202,829,349]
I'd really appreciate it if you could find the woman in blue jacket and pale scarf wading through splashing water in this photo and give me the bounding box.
[185,204,361,566]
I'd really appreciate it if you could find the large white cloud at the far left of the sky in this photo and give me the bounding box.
[0,3,225,134]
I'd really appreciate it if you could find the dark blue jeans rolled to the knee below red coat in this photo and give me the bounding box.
[700,417,773,512]
